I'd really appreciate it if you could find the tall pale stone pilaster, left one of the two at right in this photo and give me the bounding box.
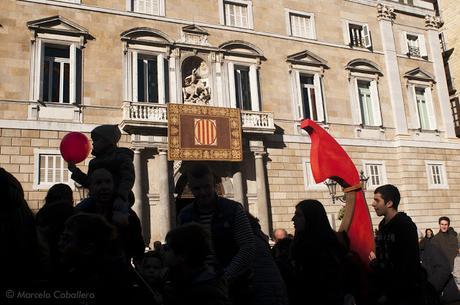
[377,3,407,134]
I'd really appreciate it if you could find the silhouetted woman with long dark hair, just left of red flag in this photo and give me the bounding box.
[288,199,347,305]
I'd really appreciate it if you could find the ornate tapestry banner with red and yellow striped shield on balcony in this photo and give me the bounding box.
[168,104,243,162]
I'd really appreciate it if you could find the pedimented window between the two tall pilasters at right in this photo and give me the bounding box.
[404,68,437,130]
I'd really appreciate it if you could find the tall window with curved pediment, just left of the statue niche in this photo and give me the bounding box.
[121,28,171,104]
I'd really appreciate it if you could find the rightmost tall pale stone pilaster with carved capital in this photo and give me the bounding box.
[425,16,456,138]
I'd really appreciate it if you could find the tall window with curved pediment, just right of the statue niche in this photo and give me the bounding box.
[220,41,264,111]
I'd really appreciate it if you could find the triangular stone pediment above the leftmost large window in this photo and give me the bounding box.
[27,16,94,43]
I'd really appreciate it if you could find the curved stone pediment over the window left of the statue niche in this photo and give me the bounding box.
[120,27,173,46]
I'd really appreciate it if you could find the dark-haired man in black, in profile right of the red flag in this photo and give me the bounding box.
[369,184,422,305]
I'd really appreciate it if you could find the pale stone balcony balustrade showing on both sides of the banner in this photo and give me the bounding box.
[120,102,275,134]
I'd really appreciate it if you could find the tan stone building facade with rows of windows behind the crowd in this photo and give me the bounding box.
[0,0,460,242]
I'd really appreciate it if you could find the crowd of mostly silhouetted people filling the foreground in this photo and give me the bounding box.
[0,125,460,305]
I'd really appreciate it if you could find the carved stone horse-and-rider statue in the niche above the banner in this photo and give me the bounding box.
[182,61,211,105]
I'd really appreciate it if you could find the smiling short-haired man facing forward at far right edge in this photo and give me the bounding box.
[434,216,458,271]
